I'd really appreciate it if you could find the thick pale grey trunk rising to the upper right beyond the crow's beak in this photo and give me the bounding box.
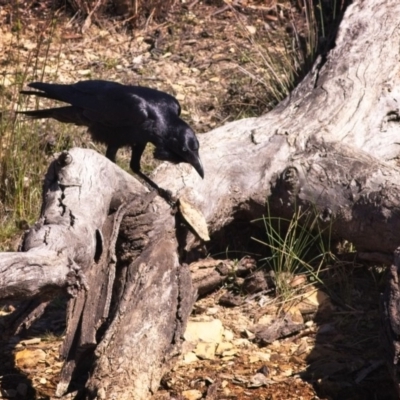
[150,0,400,256]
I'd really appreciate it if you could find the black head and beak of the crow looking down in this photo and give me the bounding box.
[154,118,204,178]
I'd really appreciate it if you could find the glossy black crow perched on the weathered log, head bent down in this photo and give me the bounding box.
[20,80,204,199]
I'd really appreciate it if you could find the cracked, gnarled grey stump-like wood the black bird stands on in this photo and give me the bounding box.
[0,149,194,400]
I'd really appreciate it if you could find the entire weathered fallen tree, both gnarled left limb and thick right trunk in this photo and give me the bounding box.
[0,0,400,400]
